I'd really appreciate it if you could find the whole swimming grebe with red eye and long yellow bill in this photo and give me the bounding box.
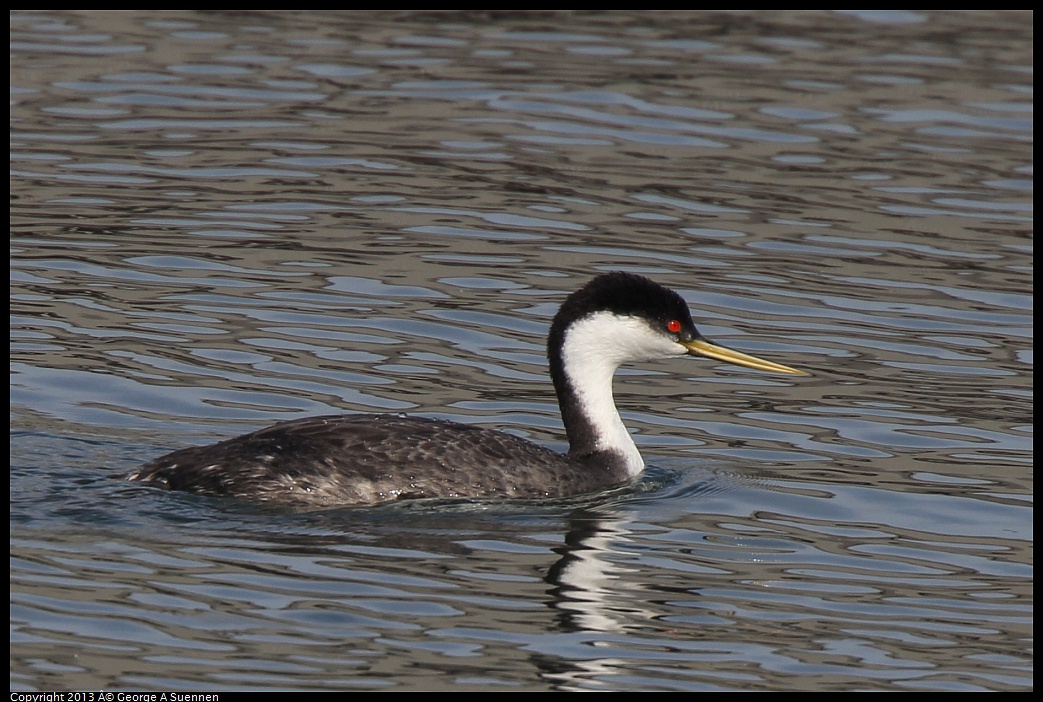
[129,272,806,507]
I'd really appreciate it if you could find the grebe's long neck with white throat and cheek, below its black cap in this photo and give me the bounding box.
[552,312,685,478]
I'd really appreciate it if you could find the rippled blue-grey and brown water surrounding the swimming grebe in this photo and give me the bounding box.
[10,11,1033,691]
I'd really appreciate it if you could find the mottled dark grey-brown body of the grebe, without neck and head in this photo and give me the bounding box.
[130,415,626,506]
